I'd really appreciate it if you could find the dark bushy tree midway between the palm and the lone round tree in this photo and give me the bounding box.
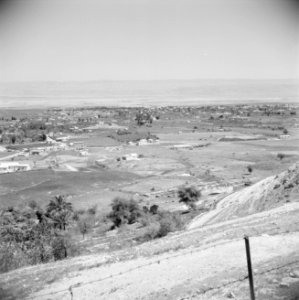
[108,197,142,227]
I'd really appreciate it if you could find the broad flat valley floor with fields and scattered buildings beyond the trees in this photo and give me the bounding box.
[0,104,299,209]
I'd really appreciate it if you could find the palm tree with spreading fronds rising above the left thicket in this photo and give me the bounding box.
[47,195,73,230]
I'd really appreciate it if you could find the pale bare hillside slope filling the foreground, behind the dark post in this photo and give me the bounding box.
[0,164,299,300]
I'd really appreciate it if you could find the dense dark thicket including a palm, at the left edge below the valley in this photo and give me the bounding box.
[0,196,73,272]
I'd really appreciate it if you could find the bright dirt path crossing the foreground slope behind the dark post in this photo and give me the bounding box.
[29,232,299,300]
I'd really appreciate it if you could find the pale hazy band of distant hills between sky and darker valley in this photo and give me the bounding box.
[0,80,299,108]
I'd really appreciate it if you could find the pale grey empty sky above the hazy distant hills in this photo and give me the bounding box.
[0,0,299,81]
